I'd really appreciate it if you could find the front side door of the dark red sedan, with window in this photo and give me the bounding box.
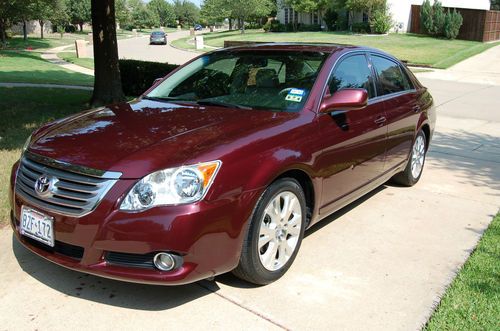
[317,53,387,213]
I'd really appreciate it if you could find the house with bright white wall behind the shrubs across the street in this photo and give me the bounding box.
[276,0,491,32]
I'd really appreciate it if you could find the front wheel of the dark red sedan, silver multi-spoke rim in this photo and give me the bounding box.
[233,178,306,285]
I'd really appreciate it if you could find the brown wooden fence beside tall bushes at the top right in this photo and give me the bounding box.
[410,5,500,42]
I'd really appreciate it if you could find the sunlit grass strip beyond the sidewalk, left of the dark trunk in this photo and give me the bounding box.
[0,51,94,86]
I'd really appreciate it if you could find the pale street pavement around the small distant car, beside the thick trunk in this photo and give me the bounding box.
[87,31,199,64]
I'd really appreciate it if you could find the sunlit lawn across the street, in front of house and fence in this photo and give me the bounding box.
[174,30,500,69]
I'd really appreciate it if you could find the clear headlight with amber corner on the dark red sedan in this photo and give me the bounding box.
[120,161,221,211]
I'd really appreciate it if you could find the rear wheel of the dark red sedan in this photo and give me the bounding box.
[392,130,427,187]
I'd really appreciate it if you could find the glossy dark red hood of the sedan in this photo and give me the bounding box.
[29,100,296,178]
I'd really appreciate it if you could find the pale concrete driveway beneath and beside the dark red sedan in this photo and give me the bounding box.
[0,50,500,330]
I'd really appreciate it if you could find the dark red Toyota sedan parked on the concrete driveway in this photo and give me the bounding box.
[10,44,436,284]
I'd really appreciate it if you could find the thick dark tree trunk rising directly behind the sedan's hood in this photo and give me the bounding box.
[90,0,125,106]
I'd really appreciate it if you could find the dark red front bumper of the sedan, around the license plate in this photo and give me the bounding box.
[9,164,258,285]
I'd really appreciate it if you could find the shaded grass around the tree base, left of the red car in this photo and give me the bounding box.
[0,87,91,227]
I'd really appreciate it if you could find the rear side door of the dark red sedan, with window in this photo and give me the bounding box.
[371,53,421,171]
